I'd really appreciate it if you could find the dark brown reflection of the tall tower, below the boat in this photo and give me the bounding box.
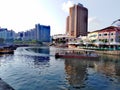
[65,59,87,86]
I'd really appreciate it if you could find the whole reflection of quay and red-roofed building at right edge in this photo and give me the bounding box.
[95,55,120,76]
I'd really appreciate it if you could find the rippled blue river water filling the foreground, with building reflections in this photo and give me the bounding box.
[0,47,120,90]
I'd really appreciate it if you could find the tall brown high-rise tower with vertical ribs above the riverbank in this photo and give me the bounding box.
[66,3,88,38]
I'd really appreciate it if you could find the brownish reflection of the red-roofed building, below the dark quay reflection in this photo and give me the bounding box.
[95,59,120,76]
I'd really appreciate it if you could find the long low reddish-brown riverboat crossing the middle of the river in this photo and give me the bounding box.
[55,50,99,59]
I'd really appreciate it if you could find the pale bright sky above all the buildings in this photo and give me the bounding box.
[0,0,120,35]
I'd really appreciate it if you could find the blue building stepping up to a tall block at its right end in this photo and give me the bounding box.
[17,24,50,42]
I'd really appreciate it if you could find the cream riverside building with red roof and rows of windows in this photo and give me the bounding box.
[88,26,120,45]
